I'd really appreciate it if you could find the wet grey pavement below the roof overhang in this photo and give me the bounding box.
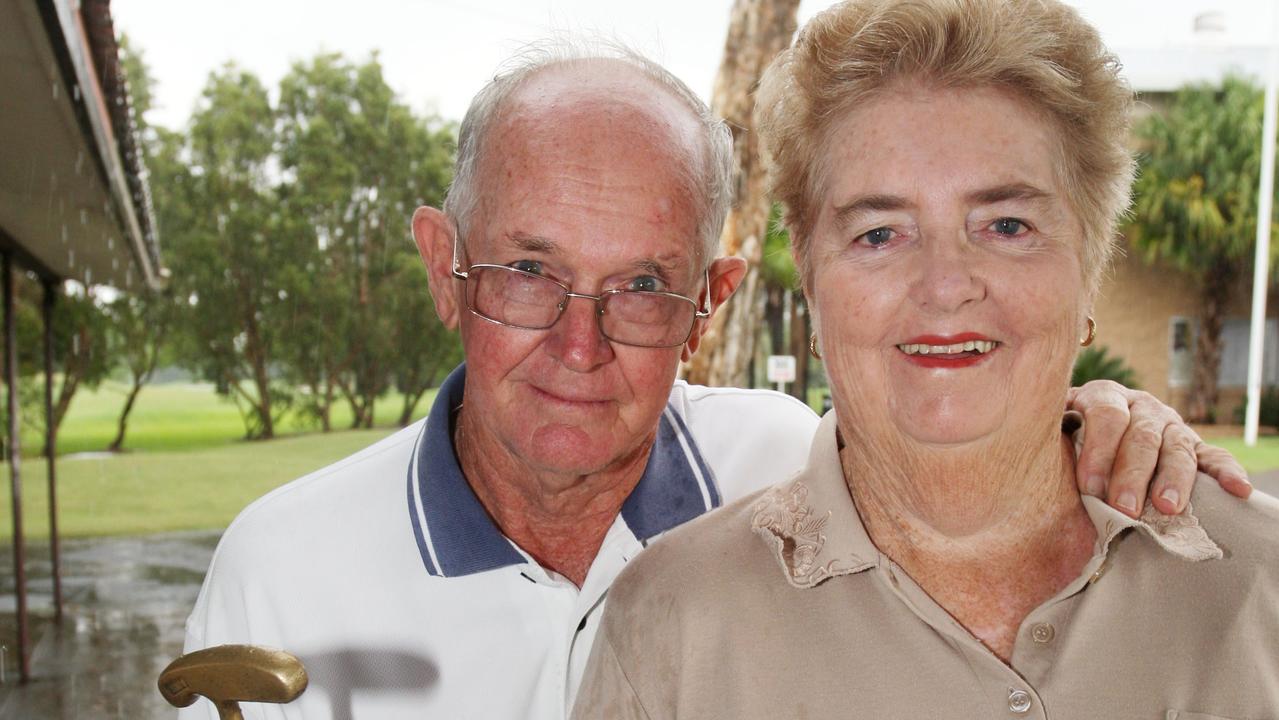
[0,532,220,720]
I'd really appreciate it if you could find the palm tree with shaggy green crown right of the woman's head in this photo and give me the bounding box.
[1127,77,1262,422]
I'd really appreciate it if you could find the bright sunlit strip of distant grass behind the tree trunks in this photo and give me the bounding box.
[22,381,435,457]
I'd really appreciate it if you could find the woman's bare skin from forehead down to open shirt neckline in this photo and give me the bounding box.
[810,84,1095,659]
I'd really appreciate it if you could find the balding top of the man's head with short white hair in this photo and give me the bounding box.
[444,38,732,263]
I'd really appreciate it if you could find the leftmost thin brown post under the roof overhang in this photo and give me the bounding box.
[3,253,31,683]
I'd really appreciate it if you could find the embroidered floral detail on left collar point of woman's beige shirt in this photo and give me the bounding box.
[751,480,851,587]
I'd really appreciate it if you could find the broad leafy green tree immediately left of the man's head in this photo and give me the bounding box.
[278,54,454,428]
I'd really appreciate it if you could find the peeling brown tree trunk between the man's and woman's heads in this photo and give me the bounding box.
[684,0,799,386]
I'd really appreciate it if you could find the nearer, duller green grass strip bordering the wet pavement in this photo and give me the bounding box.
[0,428,394,542]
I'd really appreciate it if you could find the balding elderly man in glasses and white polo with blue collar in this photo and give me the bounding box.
[187,42,1243,719]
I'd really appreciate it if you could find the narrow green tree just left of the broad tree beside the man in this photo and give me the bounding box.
[161,64,290,439]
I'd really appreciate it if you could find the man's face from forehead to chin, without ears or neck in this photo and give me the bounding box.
[454,68,705,481]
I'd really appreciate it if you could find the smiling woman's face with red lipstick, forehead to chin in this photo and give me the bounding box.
[810,84,1086,446]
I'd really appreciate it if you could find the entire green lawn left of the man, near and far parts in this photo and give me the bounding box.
[0,382,435,544]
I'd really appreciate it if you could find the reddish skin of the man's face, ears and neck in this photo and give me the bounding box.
[413,60,744,584]
